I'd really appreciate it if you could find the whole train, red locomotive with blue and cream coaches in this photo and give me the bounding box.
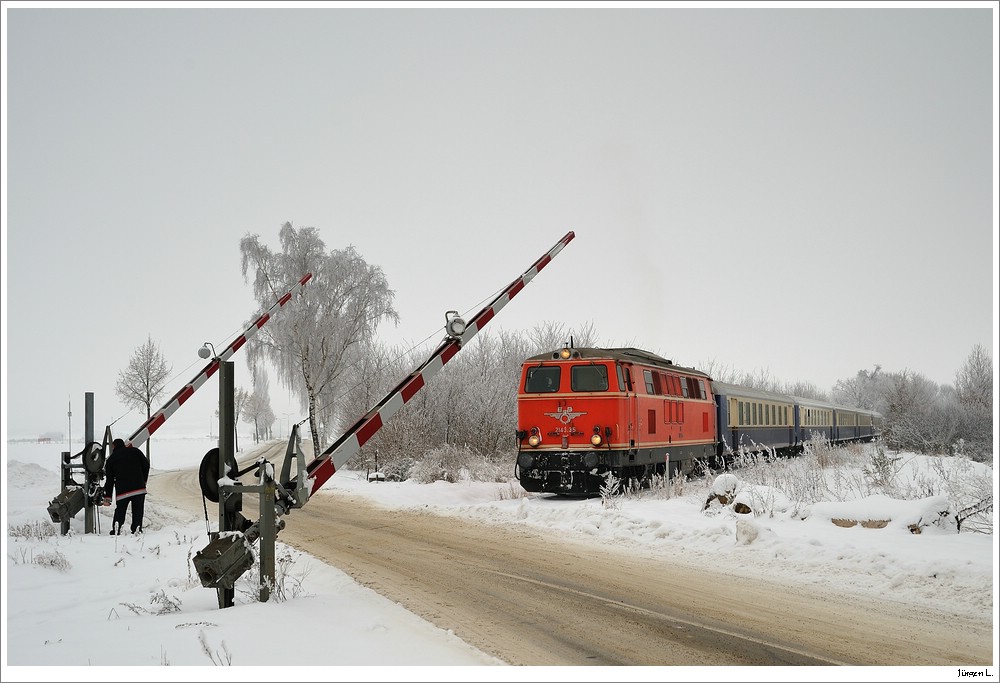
[515,344,880,496]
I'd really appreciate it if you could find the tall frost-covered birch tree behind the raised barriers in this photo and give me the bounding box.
[240,223,399,454]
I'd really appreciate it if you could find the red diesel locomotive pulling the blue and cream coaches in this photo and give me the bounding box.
[516,347,717,495]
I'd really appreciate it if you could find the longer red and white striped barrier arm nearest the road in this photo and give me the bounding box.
[300,231,576,495]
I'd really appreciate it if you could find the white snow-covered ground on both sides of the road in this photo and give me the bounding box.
[3,438,997,681]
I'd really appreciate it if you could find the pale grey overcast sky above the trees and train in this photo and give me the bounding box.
[3,3,997,444]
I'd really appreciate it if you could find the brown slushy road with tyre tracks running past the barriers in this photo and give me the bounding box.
[156,440,992,666]
